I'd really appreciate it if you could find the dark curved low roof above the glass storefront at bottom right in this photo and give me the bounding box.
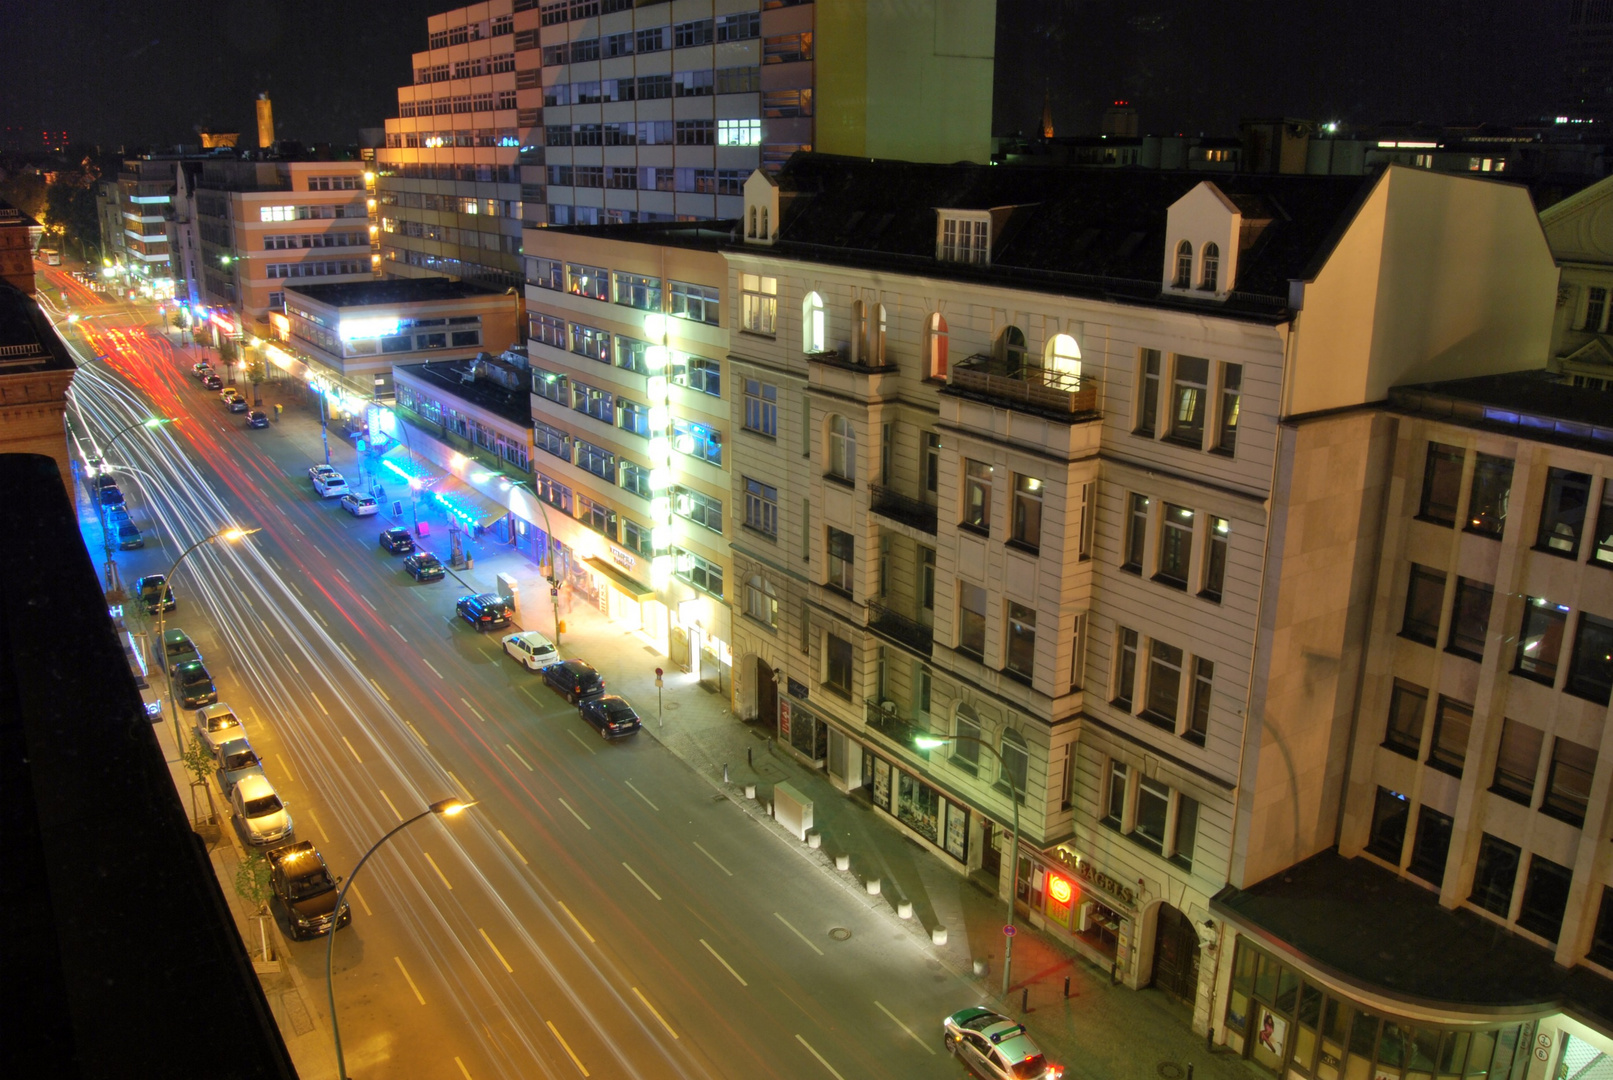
[1210,851,1613,1030]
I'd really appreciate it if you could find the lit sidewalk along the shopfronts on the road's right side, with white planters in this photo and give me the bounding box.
[452,542,1255,1080]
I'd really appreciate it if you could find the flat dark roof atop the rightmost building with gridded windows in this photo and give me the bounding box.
[1389,369,1613,453]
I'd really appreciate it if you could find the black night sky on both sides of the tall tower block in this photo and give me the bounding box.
[0,0,1568,148]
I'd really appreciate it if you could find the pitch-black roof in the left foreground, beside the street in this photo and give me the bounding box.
[0,455,297,1080]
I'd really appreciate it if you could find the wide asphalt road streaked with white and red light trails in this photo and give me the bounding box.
[56,299,977,1080]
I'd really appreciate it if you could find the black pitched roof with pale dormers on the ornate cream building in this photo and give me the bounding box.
[761,153,1376,319]
